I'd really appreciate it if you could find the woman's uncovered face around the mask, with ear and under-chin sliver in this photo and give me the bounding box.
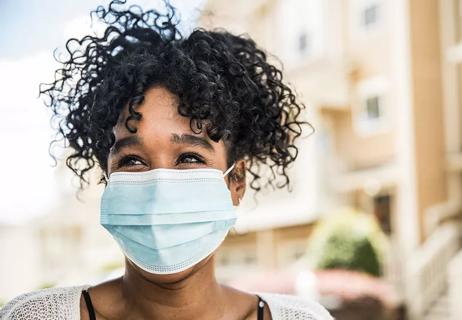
[107,87,245,282]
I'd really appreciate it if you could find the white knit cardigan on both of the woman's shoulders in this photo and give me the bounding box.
[0,285,333,320]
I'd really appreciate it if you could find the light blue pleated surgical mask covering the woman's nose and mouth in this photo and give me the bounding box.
[100,164,236,274]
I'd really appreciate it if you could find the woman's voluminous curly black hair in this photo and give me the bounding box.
[40,0,310,191]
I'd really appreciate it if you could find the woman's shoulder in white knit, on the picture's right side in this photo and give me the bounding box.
[259,293,333,320]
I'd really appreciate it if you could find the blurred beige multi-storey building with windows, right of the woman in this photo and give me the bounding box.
[201,0,462,319]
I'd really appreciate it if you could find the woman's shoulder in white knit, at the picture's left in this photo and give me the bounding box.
[0,286,88,320]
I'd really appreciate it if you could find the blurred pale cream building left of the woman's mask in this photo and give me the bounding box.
[0,162,124,304]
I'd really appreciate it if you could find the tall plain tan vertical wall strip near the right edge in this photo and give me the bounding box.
[409,0,447,241]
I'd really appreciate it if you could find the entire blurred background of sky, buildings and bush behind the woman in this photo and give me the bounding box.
[0,0,462,320]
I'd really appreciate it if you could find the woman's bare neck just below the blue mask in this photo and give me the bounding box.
[122,257,224,320]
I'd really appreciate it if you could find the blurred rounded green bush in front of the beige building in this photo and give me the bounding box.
[309,209,387,276]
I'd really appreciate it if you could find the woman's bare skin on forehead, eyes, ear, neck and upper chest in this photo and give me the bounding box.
[80,87,271,320]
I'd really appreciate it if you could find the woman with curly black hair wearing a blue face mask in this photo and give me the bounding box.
[0,1,331,320]
